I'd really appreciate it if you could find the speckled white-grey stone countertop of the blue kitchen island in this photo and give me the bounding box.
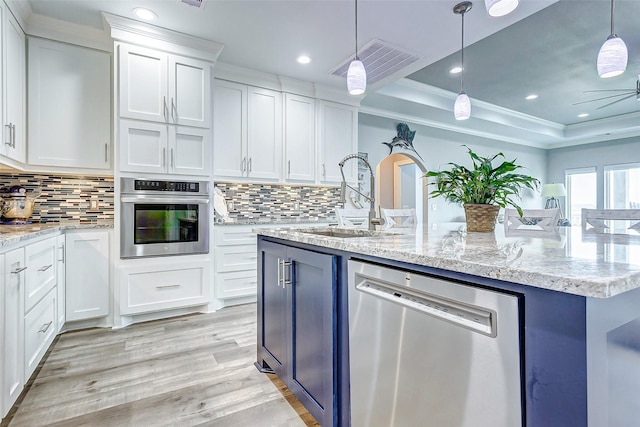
[257,224,640,298]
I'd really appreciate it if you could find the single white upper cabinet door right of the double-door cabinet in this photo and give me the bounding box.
[284,93,316,182]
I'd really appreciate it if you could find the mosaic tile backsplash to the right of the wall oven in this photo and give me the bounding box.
[215,182,340,220]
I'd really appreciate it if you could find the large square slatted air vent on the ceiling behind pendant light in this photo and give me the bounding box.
[329,39,422,85]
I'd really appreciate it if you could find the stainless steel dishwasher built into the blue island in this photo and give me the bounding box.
[349,260,522,427]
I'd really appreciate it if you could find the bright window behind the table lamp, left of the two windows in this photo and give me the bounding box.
[564,168,598,225]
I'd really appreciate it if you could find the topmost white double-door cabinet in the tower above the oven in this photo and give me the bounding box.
[119,44,211,128]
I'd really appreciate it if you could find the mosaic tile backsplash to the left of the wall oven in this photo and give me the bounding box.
[0,173,113,223]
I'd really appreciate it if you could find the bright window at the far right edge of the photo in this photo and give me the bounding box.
[604,163,640,209]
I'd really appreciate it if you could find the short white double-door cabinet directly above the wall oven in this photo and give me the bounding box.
[120,120,211,176]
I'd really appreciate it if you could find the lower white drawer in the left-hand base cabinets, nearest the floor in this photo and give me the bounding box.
[24,288,57,379]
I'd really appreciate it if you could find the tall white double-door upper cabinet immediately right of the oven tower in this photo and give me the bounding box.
[213,80,282,181]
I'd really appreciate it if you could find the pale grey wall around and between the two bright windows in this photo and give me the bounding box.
[547,138,640,212]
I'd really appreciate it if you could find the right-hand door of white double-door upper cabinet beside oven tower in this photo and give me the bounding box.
[247,87,282,180]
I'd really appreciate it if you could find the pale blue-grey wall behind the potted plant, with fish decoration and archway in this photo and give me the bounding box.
[358,113,548,224]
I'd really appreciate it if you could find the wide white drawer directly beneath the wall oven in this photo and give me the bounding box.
[120,264,209,314]
